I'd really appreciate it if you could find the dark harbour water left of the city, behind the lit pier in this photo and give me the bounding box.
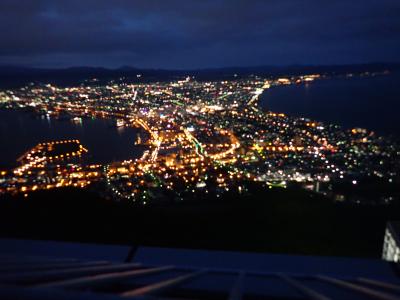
[0,109,144,167]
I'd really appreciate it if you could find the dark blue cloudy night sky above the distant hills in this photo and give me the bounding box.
[0,0,400,69]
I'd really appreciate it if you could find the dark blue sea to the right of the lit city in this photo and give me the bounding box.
[260,73,400,138]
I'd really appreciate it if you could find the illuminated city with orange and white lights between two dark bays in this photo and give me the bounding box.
[0,74,400,204]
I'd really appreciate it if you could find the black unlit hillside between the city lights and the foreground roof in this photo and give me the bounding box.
[0,189,400,257]
